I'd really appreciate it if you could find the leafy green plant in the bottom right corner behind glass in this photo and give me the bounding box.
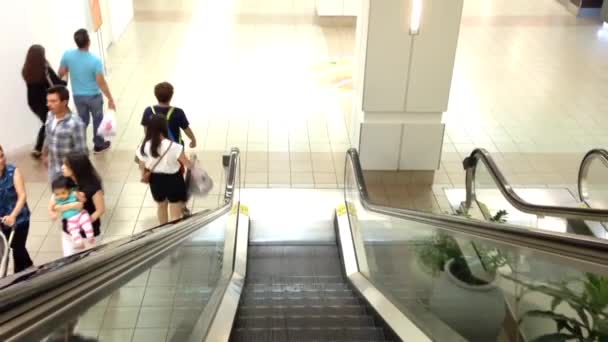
[505,273,608,342]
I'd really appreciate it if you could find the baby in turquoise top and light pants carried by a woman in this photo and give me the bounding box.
[49,176,95,248]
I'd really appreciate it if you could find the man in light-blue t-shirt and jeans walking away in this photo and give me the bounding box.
[59,29,116,153]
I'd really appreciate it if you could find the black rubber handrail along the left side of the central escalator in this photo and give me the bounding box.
[0,148,240,312]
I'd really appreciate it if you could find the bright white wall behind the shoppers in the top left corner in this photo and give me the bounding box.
[0,0,133,153]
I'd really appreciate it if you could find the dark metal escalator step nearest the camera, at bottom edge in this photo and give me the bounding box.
[231,328,385,342]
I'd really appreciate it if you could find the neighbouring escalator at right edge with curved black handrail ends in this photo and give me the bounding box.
[461,149,608,239]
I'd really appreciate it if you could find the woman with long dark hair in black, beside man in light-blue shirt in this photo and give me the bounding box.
[21,45,67,159]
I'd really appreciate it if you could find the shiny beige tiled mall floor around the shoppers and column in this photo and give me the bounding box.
[11,0,608,272]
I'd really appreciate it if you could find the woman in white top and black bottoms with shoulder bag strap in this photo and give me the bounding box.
[135,115,190,224]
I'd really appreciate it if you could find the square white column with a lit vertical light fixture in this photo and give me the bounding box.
[350,0,463,170]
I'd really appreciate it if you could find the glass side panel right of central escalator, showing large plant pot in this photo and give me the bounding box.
[346,159,608,342]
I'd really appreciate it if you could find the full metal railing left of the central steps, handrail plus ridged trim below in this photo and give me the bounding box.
[0,148,240,340]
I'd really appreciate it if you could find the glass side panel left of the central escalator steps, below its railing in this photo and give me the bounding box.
[44,216,231,342]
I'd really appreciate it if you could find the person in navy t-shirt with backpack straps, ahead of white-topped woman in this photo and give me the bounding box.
[141,82,196,148]
